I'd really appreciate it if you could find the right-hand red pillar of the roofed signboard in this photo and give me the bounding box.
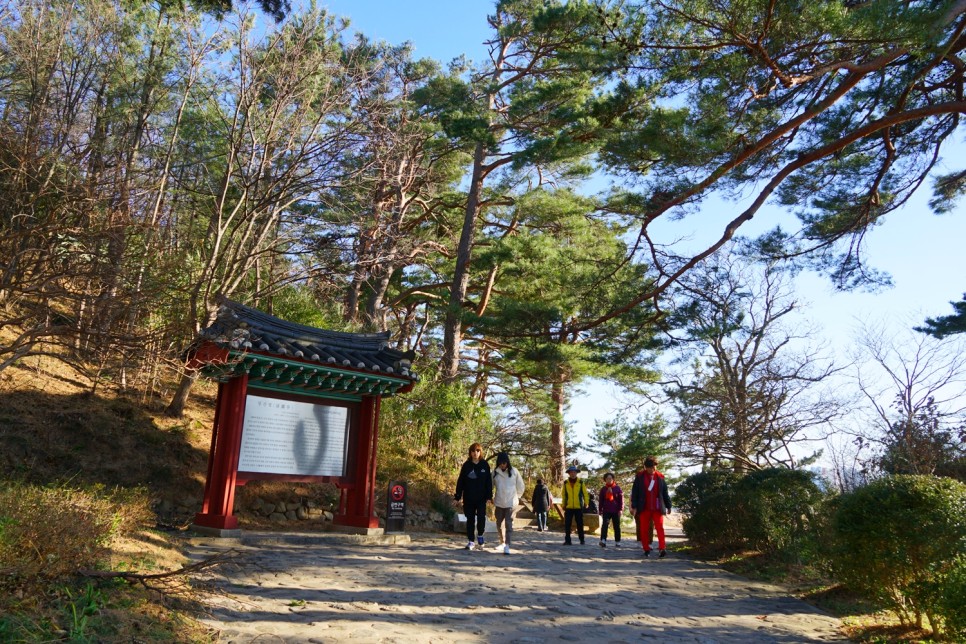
[334,396,381,529]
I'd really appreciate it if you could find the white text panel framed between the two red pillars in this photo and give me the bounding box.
[238,394,349,476]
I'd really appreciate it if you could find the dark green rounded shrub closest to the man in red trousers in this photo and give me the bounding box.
[674,470,742,548]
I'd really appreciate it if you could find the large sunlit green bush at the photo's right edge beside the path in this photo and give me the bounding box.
[831,475,966,634]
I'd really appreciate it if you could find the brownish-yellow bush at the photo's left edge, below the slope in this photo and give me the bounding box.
[0,483,149,587]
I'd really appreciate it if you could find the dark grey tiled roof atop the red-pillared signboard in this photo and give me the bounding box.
[200,298,418,381]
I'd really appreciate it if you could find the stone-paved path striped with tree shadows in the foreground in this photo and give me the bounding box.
[189,529,846,644]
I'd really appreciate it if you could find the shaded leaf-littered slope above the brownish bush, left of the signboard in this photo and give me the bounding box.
[0,358,215,502]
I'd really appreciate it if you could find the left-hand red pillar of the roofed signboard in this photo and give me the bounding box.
[194,374,248,530]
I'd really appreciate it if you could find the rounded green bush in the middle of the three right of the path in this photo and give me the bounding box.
[735,468,826,556]
